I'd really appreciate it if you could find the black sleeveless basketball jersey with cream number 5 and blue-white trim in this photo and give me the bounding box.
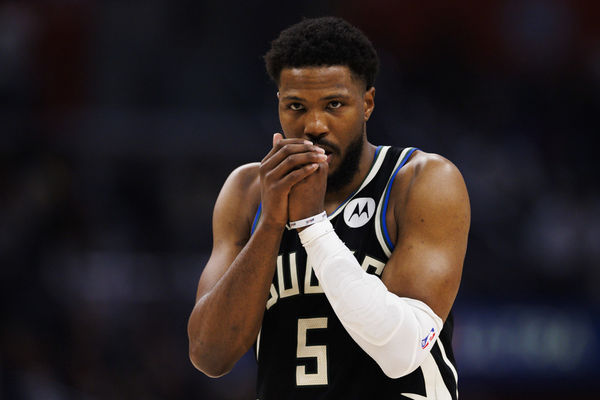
[252,146,458,400]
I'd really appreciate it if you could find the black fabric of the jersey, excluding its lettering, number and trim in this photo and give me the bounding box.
[252,148,456,400]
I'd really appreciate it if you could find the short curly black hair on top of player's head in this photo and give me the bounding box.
[264,17,379,89]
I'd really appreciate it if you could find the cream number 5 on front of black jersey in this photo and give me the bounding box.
[296,317,327,386]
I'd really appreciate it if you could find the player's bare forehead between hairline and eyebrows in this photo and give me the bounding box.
[279,65,363,94]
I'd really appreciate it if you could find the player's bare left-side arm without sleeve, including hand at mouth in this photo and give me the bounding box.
[188,136,324,377]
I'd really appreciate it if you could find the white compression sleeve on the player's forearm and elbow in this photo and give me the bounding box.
[299,220,443,378]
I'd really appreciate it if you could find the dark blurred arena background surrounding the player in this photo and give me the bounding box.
[0,0,600,400]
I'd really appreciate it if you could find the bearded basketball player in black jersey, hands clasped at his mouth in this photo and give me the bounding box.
[188,17,470,400]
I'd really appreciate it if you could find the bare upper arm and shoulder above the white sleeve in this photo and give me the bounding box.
[382,152,470,321]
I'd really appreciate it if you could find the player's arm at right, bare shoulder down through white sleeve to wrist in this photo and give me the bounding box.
[300,153,469,378]
